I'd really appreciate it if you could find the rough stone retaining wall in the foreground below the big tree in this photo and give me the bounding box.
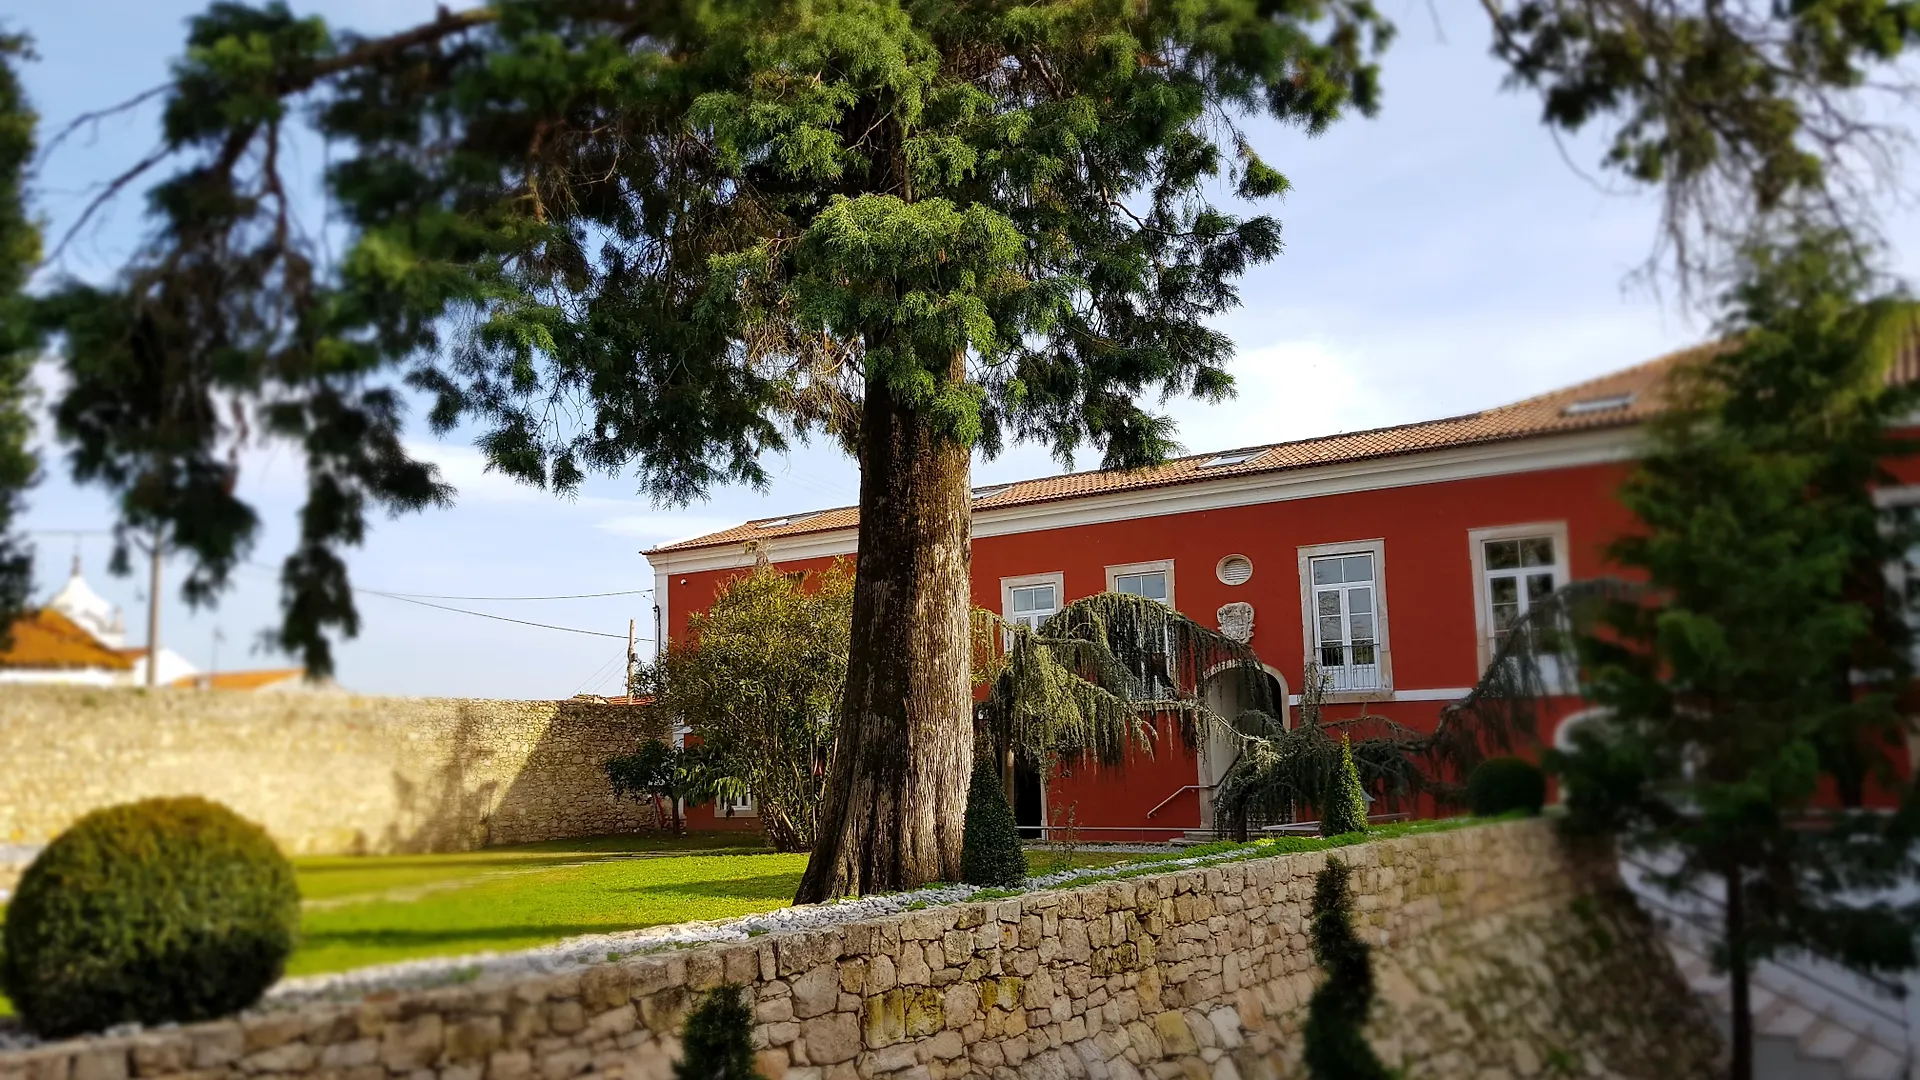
[0,822,1718,1080]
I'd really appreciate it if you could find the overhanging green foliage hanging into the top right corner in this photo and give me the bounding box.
[1488,0,1920,271]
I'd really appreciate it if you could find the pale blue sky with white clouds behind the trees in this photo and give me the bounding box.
[11,0,1920,698]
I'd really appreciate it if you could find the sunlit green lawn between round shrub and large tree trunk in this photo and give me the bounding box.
[0,834,1171,1015]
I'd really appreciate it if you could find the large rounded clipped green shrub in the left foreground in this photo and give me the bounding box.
[0,798,300,1038]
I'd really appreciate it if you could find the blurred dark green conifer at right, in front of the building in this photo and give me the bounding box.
[1482,231,1920,1065]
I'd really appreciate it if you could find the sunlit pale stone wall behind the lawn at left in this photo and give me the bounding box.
[0,686,668,857]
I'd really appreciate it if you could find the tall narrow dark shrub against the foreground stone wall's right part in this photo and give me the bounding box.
[1300,859,1392,1080]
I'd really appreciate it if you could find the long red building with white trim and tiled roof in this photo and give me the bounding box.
[647,354,1920,840]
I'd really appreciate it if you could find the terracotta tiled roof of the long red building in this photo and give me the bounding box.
[647,346,1713,555]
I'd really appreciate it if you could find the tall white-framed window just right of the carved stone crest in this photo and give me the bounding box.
[1300,540,1394,696]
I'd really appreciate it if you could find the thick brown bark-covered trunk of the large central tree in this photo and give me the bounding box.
[795,368,973,903]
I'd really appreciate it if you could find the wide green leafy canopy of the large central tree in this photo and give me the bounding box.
[50,0,1390,671]
